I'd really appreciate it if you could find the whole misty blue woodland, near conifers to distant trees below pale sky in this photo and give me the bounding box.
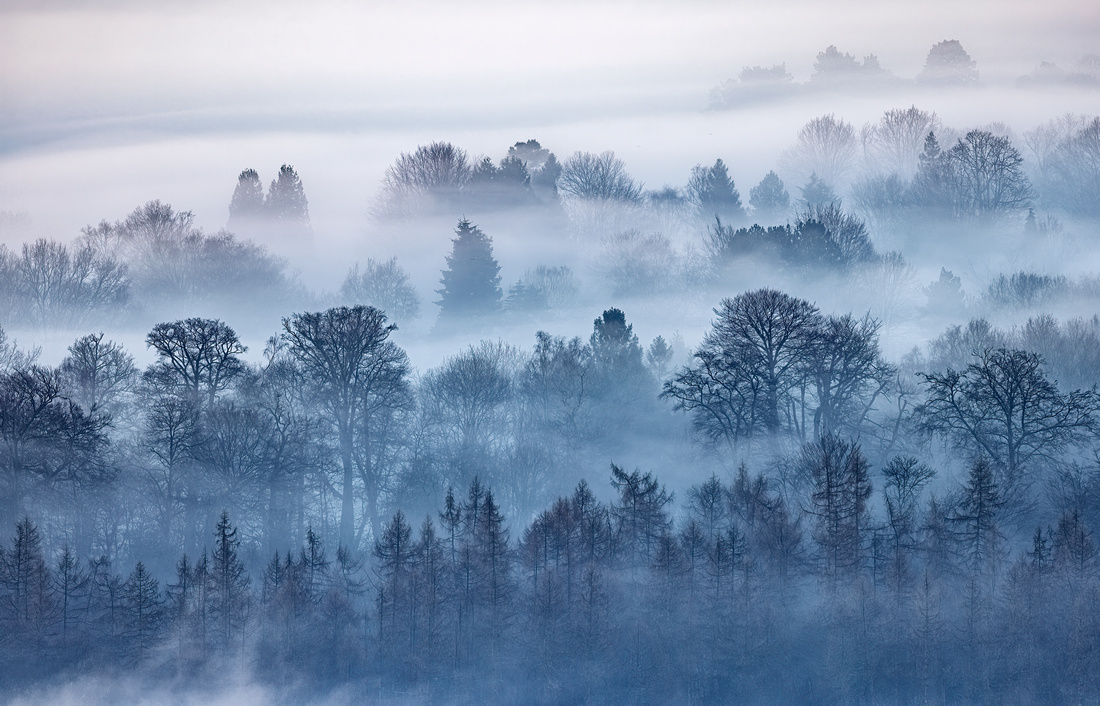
[0,87,1100,703]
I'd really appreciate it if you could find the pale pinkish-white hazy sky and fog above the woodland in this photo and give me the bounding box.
[0,0,1100,332]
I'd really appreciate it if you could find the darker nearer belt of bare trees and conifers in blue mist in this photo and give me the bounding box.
[0,289,1100,701]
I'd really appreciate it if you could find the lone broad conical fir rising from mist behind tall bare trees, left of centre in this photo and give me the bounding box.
[436,218,504,321]
